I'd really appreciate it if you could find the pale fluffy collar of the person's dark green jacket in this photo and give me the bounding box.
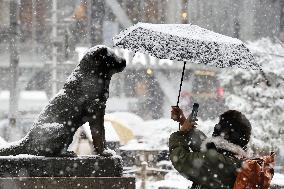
[201,137,249,158]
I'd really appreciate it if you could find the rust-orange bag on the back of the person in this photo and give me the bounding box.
[233,152,275,189]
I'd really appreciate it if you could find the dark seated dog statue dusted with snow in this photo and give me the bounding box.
[0,46,126,157]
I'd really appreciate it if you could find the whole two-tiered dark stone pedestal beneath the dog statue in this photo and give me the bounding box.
[0,155,135,189]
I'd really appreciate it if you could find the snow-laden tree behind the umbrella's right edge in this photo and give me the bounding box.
[219,38,284,152]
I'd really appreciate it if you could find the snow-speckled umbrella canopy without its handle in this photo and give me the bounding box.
[113,23,260,70]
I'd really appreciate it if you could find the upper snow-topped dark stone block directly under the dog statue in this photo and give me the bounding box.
[0,155,123,177]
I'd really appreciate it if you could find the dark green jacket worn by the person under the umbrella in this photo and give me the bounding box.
[169,129,242,189]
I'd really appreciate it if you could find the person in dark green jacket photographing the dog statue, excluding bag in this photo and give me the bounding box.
[169,107,251,189]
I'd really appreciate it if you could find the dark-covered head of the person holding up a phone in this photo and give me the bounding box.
[212,110,251,149]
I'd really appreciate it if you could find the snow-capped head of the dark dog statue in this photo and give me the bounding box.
[79,45,126,76]
